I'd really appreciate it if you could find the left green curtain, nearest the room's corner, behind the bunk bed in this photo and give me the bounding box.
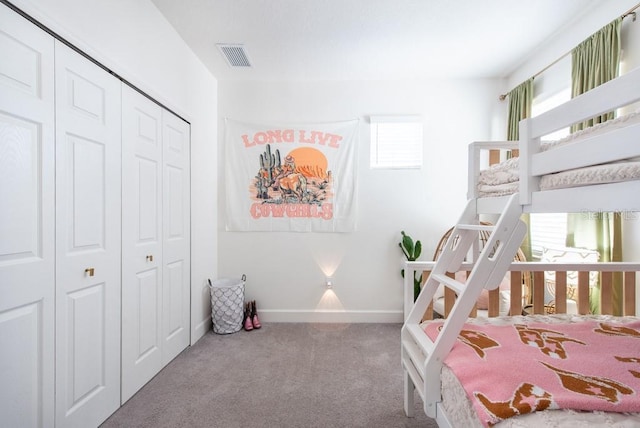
[507,77,533,261]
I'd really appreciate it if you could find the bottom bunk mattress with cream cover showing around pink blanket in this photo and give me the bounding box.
[430,314,640,428]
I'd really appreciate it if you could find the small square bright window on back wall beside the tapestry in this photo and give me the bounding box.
[371,116,423,168]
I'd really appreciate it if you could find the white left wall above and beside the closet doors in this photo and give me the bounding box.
[13,0,217,343]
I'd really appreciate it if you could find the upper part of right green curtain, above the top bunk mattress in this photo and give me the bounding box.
[571,18,622,132]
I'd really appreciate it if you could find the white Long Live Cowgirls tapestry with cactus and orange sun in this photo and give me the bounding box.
[225,119,359,232]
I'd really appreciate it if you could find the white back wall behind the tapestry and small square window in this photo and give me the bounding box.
[218,80,502,322]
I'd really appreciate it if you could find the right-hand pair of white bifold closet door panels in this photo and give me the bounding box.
[122,85,190,403]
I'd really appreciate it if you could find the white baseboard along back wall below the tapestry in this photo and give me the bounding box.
[258,309,404,324]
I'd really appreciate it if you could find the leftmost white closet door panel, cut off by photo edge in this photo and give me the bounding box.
[0,5,55,427]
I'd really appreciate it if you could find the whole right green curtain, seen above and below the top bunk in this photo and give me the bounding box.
[567,18,622,315]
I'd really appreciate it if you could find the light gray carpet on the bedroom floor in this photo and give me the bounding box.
[102,323,437,428]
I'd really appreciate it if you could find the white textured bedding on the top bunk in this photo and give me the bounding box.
[478,112,640,197]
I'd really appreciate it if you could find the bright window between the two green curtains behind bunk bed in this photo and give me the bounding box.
[529,88,571,260]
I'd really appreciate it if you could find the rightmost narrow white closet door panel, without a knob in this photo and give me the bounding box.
[162,110,191,364]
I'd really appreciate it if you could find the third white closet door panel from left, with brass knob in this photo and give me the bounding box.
[122,85,163,403]
